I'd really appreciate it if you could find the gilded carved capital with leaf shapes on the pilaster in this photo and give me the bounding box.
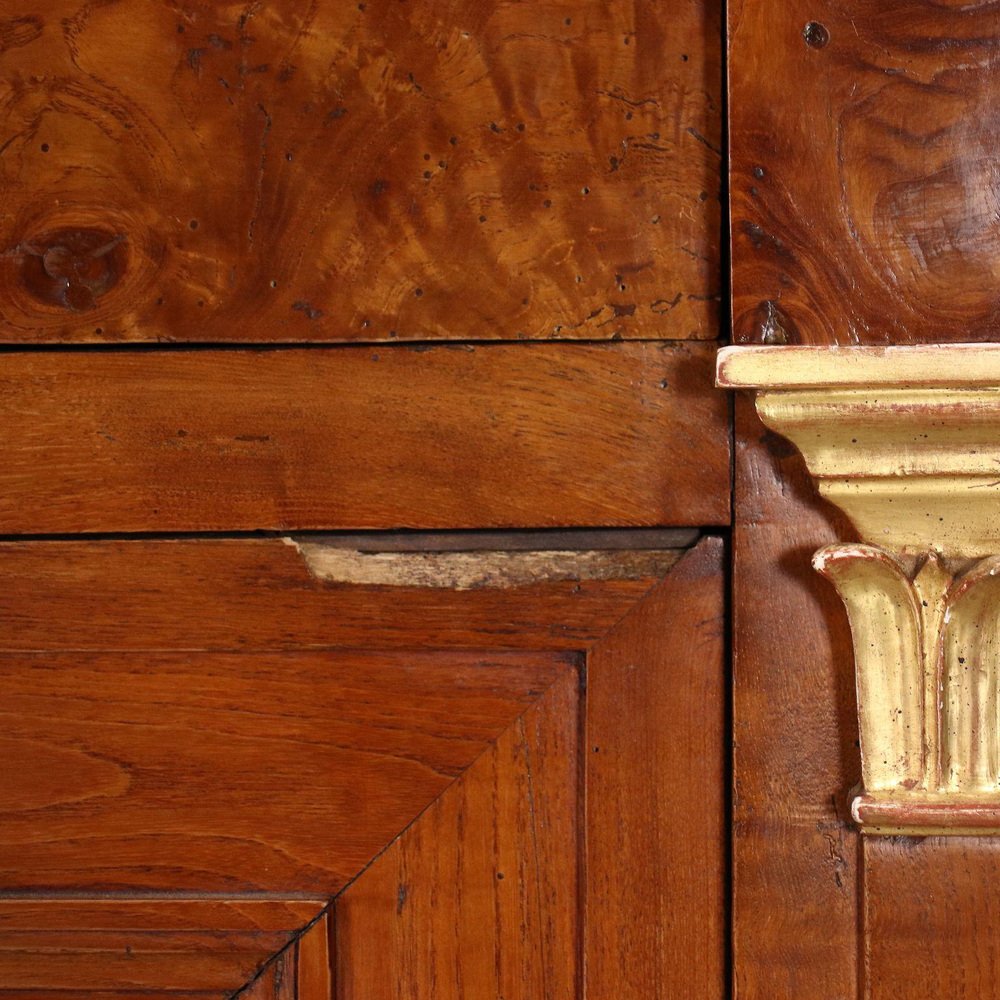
[718,344,1000,835]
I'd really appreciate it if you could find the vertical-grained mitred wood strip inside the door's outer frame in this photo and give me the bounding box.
[335,675,580,1000]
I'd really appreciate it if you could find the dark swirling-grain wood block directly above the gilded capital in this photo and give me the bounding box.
[729,0,1000,344]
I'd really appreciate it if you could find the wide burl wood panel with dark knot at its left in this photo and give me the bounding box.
[0,0,721,343]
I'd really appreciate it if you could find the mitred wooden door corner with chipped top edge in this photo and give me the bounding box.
[0,538,724,1000]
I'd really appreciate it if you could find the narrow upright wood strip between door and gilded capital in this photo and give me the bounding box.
[733,400,861,1000]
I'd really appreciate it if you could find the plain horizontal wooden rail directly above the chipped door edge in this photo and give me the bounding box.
[0,344,729,533]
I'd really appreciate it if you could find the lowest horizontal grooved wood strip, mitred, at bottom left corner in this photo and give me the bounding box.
[0,898,323,1000]
